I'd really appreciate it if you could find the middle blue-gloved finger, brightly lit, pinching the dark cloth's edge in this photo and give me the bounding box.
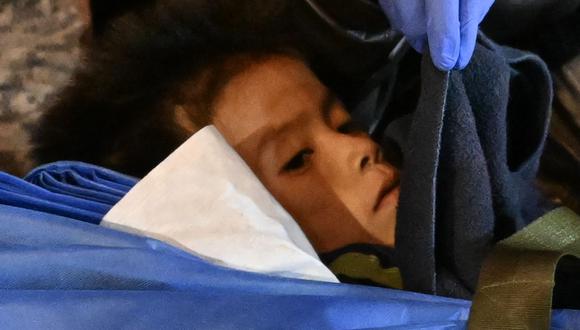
[425,0,460,71]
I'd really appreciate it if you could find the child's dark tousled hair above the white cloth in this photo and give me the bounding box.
[31,0,300,176]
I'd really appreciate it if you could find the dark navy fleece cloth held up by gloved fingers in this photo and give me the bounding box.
[385,36,552,298]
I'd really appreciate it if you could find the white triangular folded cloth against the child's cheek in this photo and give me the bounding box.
[101,126,338,282]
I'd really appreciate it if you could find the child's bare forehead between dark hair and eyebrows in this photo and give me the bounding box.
[214,56,328,145]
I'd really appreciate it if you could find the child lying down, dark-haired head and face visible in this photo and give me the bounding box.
[36,1,398,252]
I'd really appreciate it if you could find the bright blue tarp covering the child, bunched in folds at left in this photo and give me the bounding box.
[0,162,580,329]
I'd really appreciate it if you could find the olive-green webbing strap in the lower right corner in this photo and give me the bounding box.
[469,208,580,329]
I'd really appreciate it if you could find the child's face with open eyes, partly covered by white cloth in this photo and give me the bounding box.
[214,56,399,253]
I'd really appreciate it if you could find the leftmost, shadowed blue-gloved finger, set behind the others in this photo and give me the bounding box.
[379,0,426,52]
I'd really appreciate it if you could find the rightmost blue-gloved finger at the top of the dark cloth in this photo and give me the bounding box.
[455,0,494,69]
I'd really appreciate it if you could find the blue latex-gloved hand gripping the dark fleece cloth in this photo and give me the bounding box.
[379,0,494,71]
